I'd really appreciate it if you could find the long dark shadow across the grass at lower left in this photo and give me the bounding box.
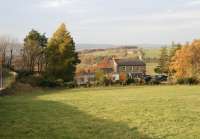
[0,99,160,139]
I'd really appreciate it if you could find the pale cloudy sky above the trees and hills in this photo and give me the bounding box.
[0,0,200,44]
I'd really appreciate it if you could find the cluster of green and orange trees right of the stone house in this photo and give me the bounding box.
[155,40,200,82]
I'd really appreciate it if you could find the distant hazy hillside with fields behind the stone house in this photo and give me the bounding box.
[77,44,163,75]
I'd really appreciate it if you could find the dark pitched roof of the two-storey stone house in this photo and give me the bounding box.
[115,59,146,66]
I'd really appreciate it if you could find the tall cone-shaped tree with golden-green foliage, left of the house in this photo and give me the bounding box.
[46,24,80,82]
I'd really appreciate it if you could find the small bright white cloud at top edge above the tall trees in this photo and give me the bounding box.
[40,0,72,8]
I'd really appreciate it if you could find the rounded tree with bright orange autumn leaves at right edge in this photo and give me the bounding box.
[170,40,200,79]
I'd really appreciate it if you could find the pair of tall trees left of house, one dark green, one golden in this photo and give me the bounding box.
[19,24,80,85]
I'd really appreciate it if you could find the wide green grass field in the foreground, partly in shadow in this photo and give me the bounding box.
[0,86,200,139]
